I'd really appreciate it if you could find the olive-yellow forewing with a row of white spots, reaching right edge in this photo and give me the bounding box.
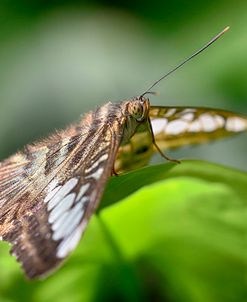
[150,106,247,149]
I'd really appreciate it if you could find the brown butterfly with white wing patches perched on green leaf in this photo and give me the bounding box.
[0,26,247,279]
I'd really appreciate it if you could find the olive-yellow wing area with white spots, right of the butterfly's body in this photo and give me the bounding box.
[115,106,247,172]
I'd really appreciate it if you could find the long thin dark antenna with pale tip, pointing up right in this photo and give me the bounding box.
[141,26,230,97]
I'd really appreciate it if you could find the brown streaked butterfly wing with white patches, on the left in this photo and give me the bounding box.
[0,116,122,278]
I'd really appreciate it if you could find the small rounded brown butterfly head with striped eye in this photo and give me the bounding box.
[127,96,150,122]
